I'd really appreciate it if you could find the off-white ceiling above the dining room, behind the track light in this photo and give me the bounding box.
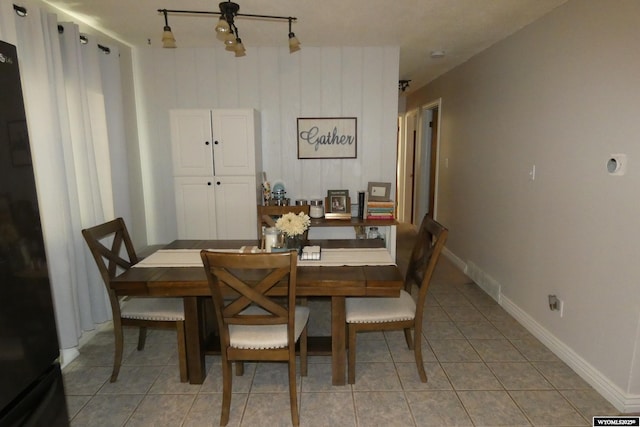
[45,0,567,93]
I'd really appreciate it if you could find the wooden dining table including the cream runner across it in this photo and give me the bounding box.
[111,239,404,385]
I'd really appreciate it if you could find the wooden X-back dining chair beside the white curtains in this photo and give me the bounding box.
[82,218,188,382]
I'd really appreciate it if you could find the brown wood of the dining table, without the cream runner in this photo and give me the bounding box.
[111,239,403,385]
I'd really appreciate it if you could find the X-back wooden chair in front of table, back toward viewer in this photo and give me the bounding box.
[200,250,309,426]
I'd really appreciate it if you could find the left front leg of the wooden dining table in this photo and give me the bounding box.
[184,297,206,384]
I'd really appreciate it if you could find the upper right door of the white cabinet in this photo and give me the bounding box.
[212,109,257,176]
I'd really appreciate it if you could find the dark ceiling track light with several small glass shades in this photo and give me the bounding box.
[158,0,300,57]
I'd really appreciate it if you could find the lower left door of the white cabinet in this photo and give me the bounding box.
[174,177,218,239]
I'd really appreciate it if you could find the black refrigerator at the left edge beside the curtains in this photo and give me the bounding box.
[0,41,69,427]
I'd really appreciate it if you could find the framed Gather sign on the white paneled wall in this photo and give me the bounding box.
[298,117,357,159]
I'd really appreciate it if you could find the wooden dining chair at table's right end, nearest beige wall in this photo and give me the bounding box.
[346,215,449,384]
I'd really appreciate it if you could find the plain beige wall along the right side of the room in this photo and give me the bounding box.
[406,0,640,411]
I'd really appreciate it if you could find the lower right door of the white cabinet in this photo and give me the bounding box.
[215,176,258,239]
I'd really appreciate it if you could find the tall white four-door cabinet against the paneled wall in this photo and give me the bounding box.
[170,109,262,239]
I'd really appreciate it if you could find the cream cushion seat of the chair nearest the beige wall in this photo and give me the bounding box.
[346,291,416,323]
